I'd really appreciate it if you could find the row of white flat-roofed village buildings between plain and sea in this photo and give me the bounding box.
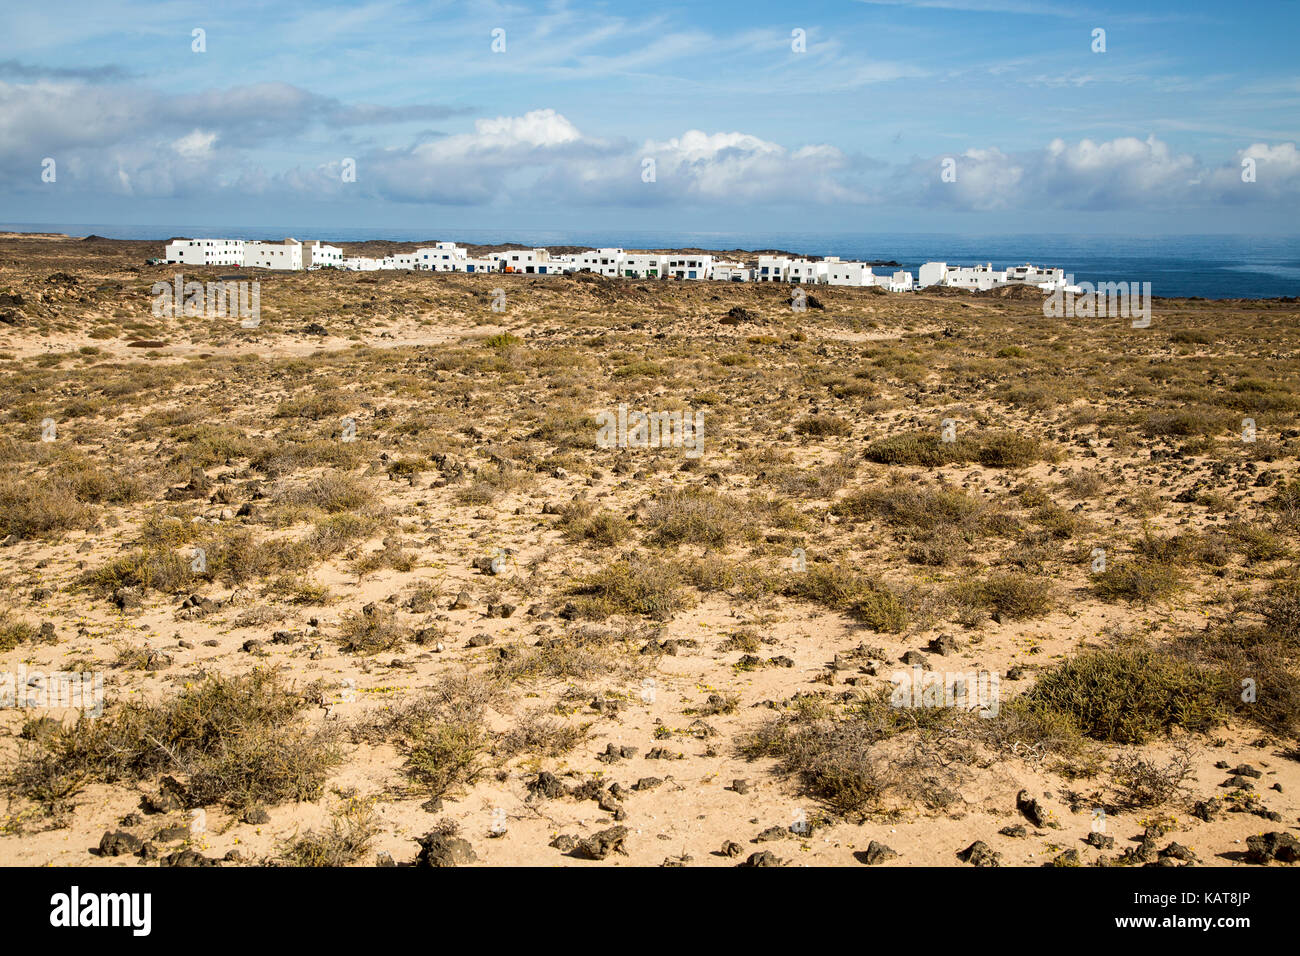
[164,238,1069,293]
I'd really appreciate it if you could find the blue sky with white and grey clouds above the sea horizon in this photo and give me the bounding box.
[0,0,1300,235]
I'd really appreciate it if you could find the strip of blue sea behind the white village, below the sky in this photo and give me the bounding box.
[0,224,1300,299]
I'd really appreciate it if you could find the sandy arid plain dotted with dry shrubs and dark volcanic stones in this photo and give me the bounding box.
[0,238,1300,866]
